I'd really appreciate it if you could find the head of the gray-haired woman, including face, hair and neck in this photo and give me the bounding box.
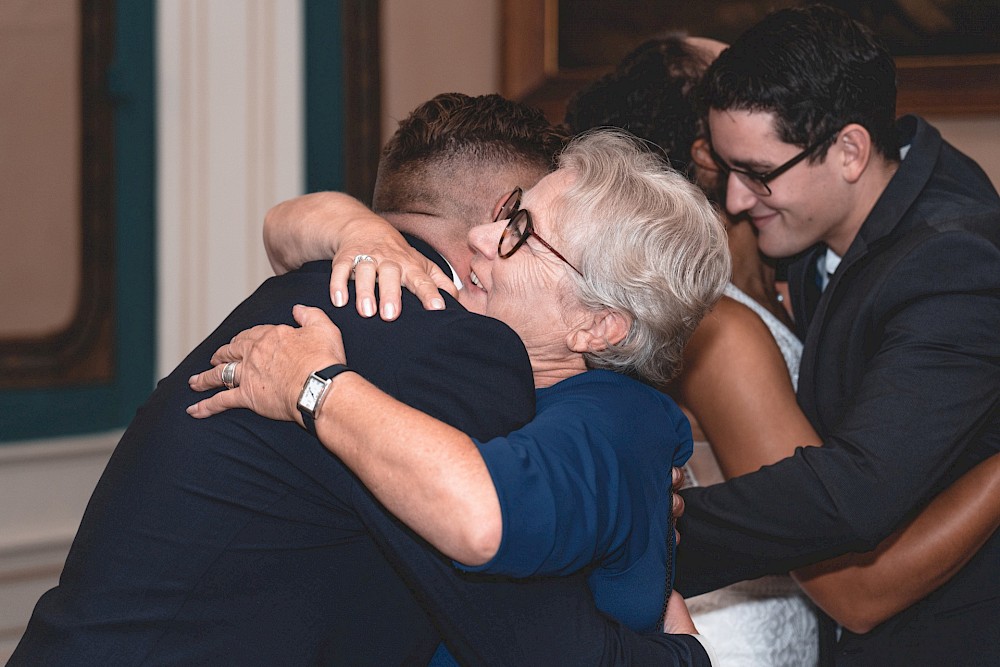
[460,129,731,387]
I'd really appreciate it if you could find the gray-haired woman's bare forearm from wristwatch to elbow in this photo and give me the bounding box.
[316,373,503,566]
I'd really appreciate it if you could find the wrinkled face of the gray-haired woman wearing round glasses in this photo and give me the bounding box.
[459,170,583,353]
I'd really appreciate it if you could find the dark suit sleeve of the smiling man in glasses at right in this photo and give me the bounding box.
[677,232,1000,595]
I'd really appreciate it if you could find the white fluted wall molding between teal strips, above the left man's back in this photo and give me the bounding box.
[157,0,304,377]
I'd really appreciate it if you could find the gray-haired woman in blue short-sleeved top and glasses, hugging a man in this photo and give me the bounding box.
[189,131,730,648]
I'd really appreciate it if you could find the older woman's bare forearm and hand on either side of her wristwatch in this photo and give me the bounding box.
[188,306,503,566]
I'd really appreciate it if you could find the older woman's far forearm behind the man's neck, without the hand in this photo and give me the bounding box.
[264,192,396,275]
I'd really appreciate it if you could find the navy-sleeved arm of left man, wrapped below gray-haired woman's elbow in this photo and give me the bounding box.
[346,472,711,667]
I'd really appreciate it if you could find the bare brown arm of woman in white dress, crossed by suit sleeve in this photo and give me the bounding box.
[677,299,1000,632]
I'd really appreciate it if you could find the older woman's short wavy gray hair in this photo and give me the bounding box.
[553,129,732,388]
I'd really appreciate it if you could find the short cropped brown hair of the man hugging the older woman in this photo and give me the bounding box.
[372,93,567,213]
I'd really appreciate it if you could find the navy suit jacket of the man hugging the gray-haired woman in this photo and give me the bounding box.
[10,240,705,665]
